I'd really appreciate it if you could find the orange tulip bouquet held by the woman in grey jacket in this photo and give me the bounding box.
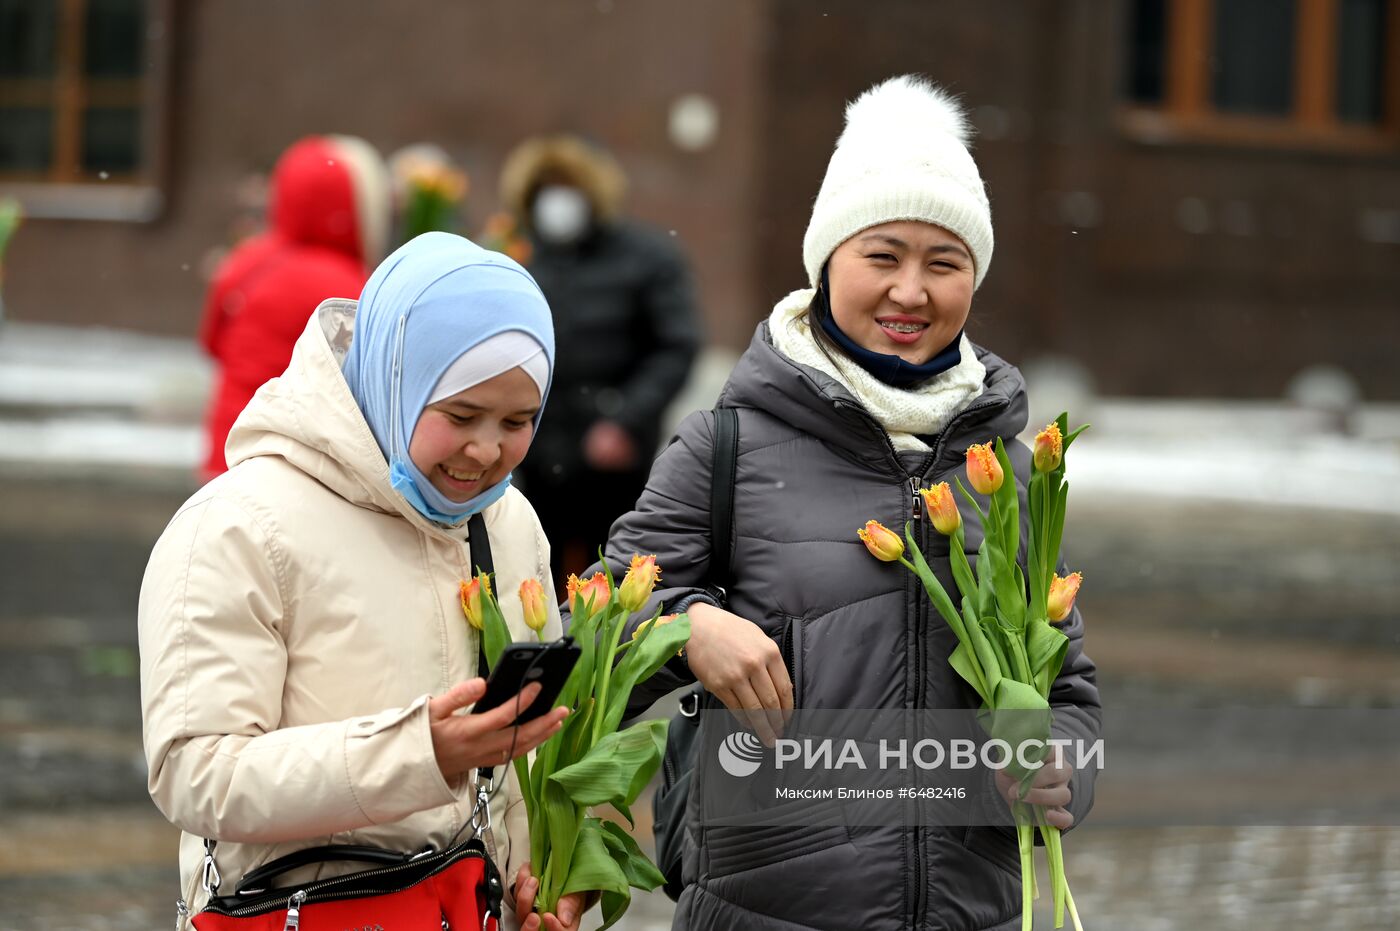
[858,414,1085,931]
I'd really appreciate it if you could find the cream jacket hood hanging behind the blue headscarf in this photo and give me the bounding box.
[228,298,442,532]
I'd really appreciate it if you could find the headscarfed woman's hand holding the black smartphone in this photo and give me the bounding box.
[428,679,568,780]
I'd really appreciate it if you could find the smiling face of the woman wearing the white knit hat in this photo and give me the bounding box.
[827,220,976,365]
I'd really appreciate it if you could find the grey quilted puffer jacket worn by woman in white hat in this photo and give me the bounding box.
[576,322,1099,931]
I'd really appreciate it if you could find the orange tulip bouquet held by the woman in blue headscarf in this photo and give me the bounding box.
[462,556,690,928]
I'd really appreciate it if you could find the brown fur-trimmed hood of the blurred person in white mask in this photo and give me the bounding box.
[501,136,627,228]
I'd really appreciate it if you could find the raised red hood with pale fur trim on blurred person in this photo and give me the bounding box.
[267,136,389,265]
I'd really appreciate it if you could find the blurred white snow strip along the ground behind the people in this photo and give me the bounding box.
[0,323,1400,515]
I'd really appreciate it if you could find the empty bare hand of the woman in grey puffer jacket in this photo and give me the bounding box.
[686,603,792,746]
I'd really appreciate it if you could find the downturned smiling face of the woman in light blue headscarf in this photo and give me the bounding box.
[409,368,540,503]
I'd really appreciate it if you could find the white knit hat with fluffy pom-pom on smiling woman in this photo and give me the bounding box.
[802,74,991,288]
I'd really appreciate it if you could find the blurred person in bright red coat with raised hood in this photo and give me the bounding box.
[199,136,391,480]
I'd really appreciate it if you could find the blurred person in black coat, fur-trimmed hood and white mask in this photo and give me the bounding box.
[501,136,700,575]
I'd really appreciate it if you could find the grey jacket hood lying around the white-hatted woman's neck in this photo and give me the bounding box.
[720,313,1028,470]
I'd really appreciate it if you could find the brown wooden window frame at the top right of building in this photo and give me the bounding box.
[1117,0,1400,153]
